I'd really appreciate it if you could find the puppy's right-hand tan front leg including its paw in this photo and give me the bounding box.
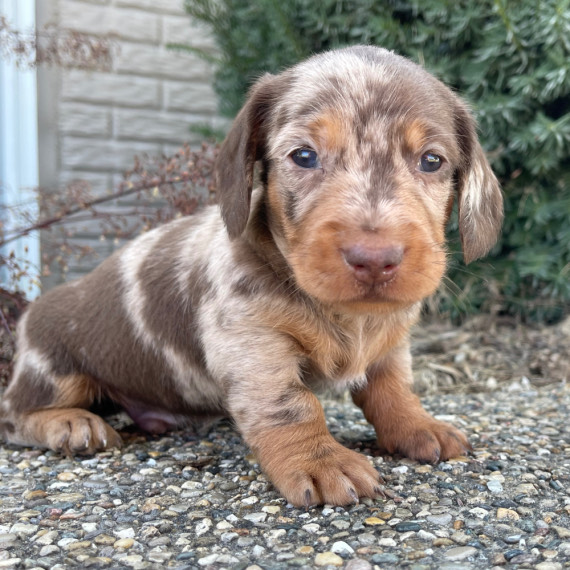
[352,346,471,463]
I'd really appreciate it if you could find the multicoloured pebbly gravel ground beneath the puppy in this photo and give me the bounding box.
[0,382,570,570]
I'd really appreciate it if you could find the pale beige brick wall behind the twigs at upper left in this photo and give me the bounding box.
[37,0,222,287]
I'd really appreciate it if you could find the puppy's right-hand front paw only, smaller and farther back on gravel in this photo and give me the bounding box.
[378,414,471,463]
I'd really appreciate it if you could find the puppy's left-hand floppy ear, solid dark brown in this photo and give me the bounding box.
[214,74,282,239]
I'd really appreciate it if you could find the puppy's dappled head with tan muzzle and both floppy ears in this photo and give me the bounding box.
[216,46,503,310]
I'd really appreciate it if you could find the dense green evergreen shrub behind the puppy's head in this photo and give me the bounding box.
[186,0,570,321]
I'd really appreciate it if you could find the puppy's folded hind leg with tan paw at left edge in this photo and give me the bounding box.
[0,362,121,454]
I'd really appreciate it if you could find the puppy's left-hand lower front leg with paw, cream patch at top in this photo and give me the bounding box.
[224,378,381,507]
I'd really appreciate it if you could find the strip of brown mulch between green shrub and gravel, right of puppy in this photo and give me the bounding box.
[412,315,570,393]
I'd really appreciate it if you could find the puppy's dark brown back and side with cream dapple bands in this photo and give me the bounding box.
[6,208,225,414]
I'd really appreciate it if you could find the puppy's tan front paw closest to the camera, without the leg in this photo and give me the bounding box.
[261,436,382,507]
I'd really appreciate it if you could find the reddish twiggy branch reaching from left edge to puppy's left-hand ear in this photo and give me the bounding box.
[0,143,218,281]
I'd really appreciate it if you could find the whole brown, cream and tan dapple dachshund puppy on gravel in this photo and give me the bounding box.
[0,46,503,506]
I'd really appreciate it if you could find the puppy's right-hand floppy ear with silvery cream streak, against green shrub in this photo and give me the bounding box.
[455,101,503,263]
